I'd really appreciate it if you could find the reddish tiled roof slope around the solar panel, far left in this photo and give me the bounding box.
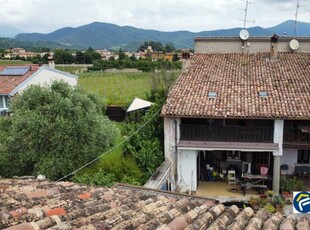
[0,65,40,95]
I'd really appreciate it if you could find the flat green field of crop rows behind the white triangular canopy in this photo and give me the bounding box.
[78,72,154,105]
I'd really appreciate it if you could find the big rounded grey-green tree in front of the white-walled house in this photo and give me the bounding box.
[0,82,118,179]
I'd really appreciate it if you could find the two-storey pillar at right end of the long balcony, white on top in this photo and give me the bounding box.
[272,120,284,193]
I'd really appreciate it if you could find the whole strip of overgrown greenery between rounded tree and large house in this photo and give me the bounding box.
[73,71,178,186]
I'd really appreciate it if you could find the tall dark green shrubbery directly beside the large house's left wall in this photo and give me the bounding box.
[124,71,177,182]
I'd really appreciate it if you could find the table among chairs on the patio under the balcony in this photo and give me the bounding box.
[240,174,269,196]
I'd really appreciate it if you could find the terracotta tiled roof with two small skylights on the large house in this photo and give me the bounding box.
[162,52,310,119]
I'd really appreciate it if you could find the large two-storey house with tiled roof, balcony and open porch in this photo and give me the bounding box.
[162,37,310,192]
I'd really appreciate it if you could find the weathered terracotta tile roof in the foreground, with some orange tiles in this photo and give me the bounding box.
[0,179,310,230]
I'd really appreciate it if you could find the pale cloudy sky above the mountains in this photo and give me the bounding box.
[0,0,310,33]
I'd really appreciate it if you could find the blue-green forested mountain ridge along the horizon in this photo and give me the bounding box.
[11,20,310,50]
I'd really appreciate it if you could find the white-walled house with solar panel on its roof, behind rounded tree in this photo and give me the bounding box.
[0,65,77,112]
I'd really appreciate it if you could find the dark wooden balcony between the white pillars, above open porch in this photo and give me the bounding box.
[180,124,273,143]
